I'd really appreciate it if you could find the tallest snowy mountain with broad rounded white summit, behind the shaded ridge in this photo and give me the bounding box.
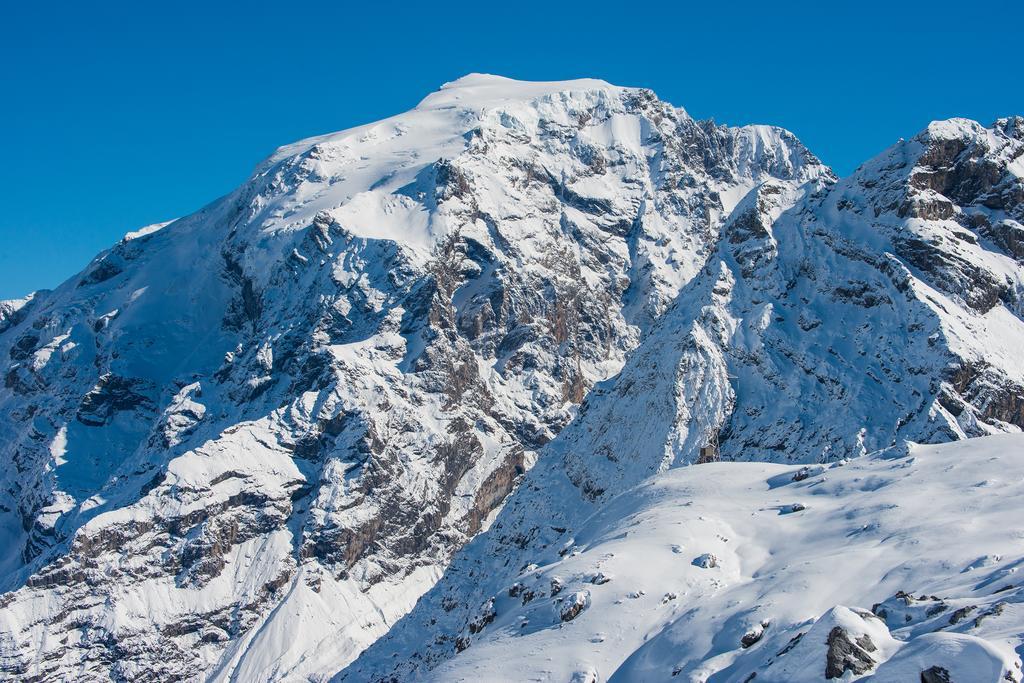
[0,76,830,680]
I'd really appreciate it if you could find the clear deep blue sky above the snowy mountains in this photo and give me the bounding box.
[0,0,1024,298]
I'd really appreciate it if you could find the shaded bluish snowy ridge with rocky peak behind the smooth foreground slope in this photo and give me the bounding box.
[345,119,1024,680]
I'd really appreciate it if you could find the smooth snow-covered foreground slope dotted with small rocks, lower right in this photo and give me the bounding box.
[345,435,1024,683]
